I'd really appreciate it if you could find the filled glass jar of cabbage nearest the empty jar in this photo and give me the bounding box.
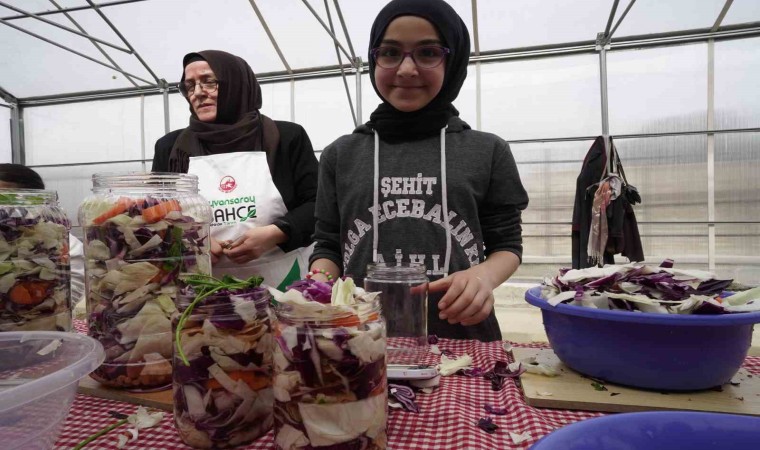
[273,298,388,450]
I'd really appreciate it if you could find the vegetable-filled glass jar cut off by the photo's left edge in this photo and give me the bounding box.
[0,189,71,331]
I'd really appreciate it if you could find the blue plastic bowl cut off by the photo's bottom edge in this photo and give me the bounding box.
[530,411,760,450]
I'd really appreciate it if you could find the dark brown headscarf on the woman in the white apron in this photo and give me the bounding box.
[169,50,280,173]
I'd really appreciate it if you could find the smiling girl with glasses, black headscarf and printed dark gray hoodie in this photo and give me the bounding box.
[311,0,528,341]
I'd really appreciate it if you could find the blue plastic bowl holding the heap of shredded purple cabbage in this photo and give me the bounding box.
[525,287,760,391]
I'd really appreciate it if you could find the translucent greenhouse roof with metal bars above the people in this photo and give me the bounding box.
[0,0,760,105]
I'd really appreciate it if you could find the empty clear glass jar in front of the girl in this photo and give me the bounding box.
[364,263,428,365]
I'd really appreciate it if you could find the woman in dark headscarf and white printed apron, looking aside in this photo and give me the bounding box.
[153,50,318,290]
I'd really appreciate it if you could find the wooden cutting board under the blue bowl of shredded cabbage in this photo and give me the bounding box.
[512,348,760,416]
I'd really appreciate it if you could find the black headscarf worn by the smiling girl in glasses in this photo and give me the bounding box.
[367,0,470,141]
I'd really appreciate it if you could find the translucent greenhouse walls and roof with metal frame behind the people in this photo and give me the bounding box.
[0,0,760,284]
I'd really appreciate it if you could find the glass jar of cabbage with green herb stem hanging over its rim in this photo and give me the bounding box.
[173,288,274,448]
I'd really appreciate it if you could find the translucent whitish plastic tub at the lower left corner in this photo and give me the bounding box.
[0,331,104,450]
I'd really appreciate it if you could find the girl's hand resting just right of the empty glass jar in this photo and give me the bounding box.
[428,269,494,326]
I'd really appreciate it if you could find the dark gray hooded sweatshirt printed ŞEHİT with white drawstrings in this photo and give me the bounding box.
[311,117,528,341]
